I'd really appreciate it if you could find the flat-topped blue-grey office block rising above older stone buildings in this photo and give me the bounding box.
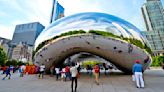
[11,22,45,46]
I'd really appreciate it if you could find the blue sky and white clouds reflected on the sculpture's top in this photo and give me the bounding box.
[35,12,146,48]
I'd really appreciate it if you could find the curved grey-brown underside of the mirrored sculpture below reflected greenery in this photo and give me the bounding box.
[34,34,151,73]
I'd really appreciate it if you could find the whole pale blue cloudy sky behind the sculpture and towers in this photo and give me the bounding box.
[0,0,164,39]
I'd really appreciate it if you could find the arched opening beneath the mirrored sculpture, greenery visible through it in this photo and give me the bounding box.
[52,52,118,69]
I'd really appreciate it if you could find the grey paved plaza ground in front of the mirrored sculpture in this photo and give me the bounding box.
[0,69,164,92]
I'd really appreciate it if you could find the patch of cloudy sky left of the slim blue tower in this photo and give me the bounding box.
[0,0,52,39]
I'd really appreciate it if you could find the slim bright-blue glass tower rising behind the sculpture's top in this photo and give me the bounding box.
[50,0,64,23]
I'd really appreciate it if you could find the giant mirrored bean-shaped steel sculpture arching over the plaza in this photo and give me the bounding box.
[34,12,152,73]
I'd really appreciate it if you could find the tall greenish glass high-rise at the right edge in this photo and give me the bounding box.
[141,0,164,55]
